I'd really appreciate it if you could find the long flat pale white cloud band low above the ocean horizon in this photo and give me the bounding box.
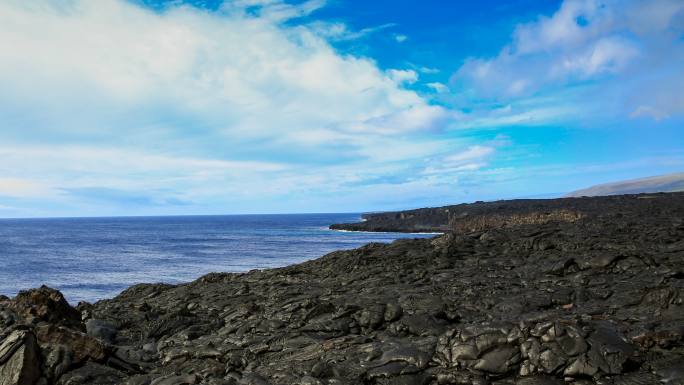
[0,137,464,215]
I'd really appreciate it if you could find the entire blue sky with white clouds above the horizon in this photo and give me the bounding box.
[0,0,684,217]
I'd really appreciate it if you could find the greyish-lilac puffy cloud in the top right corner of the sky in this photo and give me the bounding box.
[452,0,684,117]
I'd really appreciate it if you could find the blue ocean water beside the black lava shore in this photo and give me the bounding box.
[0,214,436,304]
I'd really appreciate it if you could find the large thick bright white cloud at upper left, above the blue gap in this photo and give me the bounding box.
[0,0,438,142]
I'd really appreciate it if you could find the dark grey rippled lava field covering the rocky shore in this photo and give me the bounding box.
[0,193,684,385]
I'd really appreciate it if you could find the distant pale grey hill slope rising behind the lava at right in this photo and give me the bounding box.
[566,172,684,197]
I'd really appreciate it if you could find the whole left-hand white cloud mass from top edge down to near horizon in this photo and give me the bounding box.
[0,0,462,213]
